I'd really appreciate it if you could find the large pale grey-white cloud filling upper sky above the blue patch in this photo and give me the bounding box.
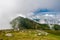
[0,0,60,29]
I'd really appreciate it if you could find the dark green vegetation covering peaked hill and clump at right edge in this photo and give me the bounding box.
[10,16,60,30]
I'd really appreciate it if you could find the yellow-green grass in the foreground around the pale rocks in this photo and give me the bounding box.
[0,30,60,40]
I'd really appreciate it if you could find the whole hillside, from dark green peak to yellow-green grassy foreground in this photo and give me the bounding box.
[0,16,60,40]
